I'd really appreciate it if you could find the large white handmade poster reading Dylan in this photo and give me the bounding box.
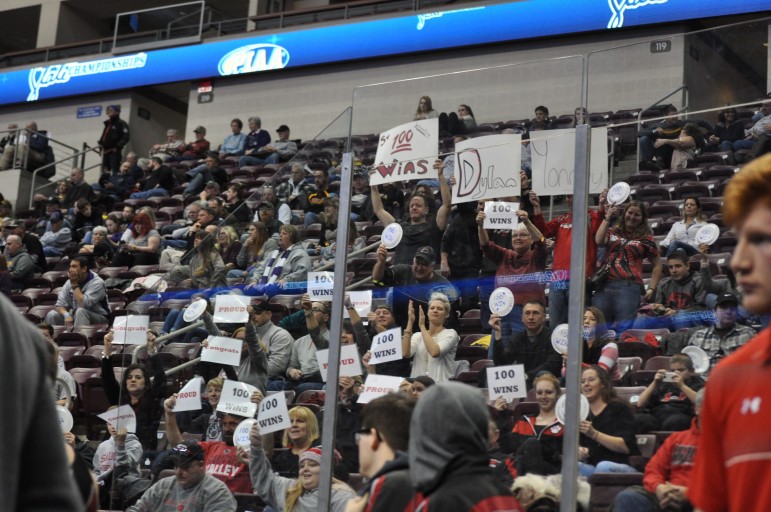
[452,134,522,204]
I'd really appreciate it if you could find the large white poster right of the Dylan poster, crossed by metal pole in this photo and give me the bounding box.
[530,126,608,196]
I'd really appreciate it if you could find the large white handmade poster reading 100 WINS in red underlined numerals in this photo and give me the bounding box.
[369,118,439,185]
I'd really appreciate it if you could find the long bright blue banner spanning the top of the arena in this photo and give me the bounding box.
[0,0,771,105]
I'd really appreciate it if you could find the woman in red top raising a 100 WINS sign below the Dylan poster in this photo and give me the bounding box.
[476,210,548,336]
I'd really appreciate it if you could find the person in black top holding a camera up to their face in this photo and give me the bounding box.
[634,354,704,434]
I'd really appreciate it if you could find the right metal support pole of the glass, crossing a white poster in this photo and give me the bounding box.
[560,124,591,512]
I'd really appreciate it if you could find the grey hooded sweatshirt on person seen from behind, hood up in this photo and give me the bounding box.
[408,382,523,512]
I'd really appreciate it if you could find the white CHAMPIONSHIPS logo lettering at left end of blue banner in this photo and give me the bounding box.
[27,52,147,101]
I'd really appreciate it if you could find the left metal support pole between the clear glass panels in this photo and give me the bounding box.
[319,153,353,510]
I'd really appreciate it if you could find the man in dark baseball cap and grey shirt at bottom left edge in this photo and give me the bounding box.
[128,441,236,512]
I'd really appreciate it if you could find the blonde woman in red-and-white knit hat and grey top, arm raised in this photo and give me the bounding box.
[249,423,356,512]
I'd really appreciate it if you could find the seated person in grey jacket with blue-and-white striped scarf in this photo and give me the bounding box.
[247,225,311,295]
